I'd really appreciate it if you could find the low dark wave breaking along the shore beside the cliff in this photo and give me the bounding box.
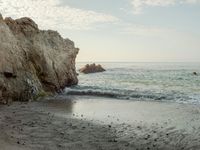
[64,86,189,101]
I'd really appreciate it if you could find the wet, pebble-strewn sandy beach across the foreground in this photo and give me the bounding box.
[0,96,200,150]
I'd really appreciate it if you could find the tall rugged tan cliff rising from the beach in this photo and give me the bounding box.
[0,15,79,103]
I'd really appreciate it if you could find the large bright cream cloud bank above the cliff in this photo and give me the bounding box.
[0,0,118,30]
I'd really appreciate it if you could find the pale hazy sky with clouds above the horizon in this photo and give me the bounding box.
[0,0,200,62]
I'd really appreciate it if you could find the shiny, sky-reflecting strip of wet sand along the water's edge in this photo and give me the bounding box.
[35,96,200,130]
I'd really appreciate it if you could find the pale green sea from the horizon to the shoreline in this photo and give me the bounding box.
[65,62,200,104]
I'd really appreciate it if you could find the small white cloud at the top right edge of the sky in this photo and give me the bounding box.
[131,0,200,14]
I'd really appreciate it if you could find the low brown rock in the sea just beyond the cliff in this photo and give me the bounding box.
[79,64,106,74]
